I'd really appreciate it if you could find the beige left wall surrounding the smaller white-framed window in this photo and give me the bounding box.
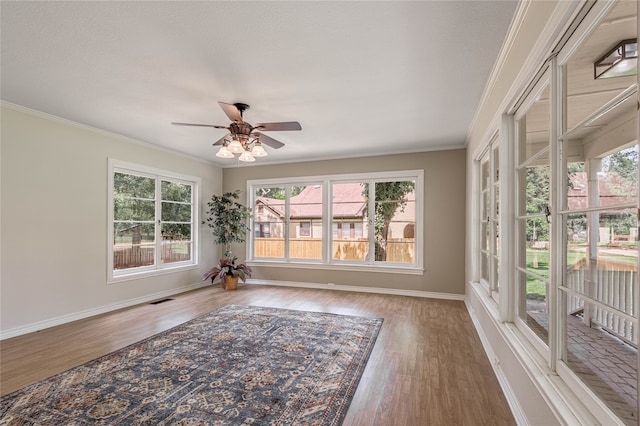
[0,104,222,333]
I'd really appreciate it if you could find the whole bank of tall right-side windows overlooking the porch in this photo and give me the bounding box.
[474,1,640,424]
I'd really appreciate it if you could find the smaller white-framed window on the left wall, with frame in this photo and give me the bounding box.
[109,161,198,281]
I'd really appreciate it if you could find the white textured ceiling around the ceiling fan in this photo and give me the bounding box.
[0,0,517,166]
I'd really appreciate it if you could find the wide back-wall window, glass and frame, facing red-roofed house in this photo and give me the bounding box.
[248,171,423,269]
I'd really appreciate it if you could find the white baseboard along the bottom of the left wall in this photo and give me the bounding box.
[0,282,210,340]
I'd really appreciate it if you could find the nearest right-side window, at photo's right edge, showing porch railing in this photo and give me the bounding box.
[557,1,639,424]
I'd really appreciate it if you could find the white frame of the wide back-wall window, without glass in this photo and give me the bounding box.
[247,170,424,275]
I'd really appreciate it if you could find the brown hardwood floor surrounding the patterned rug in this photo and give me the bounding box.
[0,285,515,426]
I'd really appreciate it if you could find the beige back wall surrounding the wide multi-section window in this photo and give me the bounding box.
[223,150,466,294]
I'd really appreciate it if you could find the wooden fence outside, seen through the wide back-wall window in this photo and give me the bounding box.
[254,238,415,263]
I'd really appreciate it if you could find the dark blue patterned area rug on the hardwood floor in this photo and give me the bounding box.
[0,305,382,426]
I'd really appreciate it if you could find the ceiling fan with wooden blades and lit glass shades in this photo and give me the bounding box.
[171,102,302,162]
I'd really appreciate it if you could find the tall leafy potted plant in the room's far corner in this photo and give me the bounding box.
[202,190,251,290]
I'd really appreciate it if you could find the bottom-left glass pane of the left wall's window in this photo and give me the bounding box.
[113,222,155,269]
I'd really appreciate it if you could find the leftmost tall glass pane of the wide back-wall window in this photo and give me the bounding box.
[253,187,286,258]
